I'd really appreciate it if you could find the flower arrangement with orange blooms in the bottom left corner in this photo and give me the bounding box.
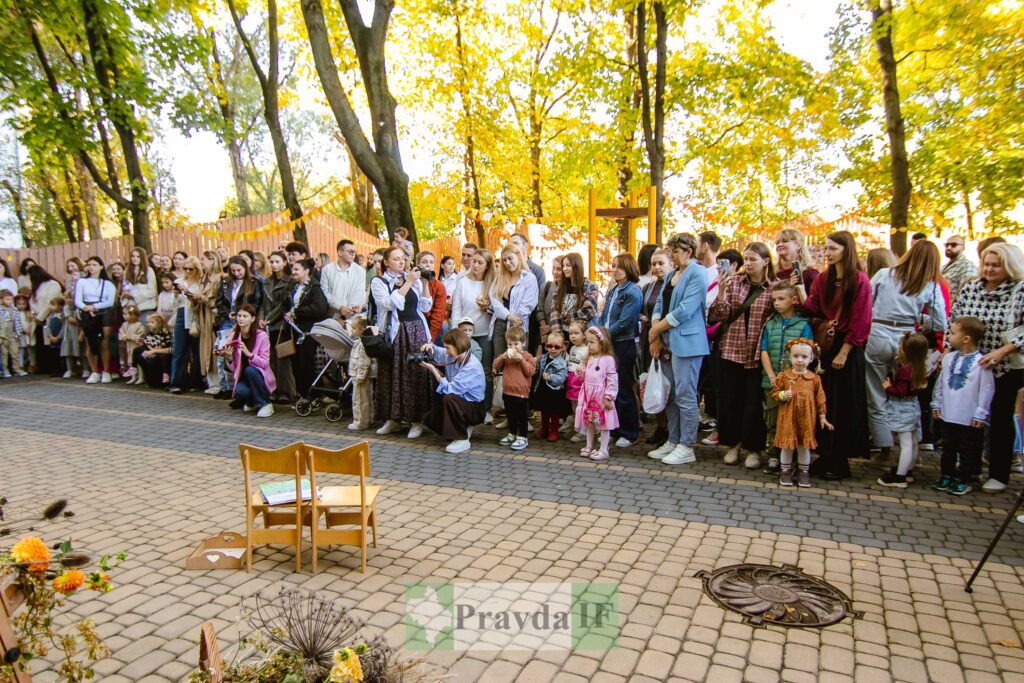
[0,498,126,683]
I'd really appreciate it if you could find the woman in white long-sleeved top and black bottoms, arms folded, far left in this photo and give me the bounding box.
[75,256,117,384]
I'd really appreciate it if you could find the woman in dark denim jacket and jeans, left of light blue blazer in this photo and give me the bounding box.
[597,254,643,449]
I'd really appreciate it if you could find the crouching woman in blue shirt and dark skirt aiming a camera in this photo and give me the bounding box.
[410,330,484,453]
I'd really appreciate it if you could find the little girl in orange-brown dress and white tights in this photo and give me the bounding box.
[772,338,833,486]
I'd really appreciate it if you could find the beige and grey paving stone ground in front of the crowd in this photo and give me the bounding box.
[0,380,1024,683]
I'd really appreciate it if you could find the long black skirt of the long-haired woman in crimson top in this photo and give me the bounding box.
[811,334,869,477]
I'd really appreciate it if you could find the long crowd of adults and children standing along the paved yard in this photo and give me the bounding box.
[0,229,1024,495]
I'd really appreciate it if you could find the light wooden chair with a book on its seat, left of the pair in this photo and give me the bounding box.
[239,441,307,571]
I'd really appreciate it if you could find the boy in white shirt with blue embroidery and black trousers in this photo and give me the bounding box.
[932,316,995,496]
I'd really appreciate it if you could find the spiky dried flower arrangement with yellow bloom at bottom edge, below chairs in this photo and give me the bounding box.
[188,589,446,683]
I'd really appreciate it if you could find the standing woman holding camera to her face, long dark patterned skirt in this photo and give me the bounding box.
[370,246,433,438]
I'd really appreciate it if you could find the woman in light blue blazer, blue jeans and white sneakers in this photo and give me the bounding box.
[647,232,708,465]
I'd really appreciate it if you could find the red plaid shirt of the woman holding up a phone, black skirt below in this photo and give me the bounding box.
[708,278,775,368]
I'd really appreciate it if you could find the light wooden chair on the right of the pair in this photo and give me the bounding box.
[306,441,380,573]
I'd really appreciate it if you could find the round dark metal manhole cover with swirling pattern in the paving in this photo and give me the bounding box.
[696,564,860,628]
